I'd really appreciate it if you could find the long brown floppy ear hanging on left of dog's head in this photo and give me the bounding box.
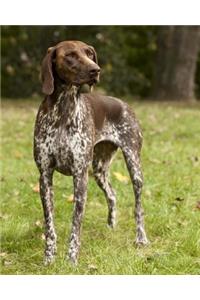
[42,47,56,95]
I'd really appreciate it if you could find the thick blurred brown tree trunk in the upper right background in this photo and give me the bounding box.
[154,26,200,101]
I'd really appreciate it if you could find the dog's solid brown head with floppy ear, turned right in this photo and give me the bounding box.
[42,41,100,95]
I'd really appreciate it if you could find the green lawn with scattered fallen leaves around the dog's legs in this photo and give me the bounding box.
[0,99,200,274]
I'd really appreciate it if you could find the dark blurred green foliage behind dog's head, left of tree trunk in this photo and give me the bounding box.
[2,26,157,98]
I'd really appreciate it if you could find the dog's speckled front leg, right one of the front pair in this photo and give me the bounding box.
[69,170,88,264]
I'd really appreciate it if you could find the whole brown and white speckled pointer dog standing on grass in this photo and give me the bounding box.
[34,41,148,264]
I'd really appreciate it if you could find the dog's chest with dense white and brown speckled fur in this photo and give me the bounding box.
[36,90,94,175]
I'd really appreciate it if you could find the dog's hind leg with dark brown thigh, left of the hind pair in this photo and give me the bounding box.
[92,142,118,228]
